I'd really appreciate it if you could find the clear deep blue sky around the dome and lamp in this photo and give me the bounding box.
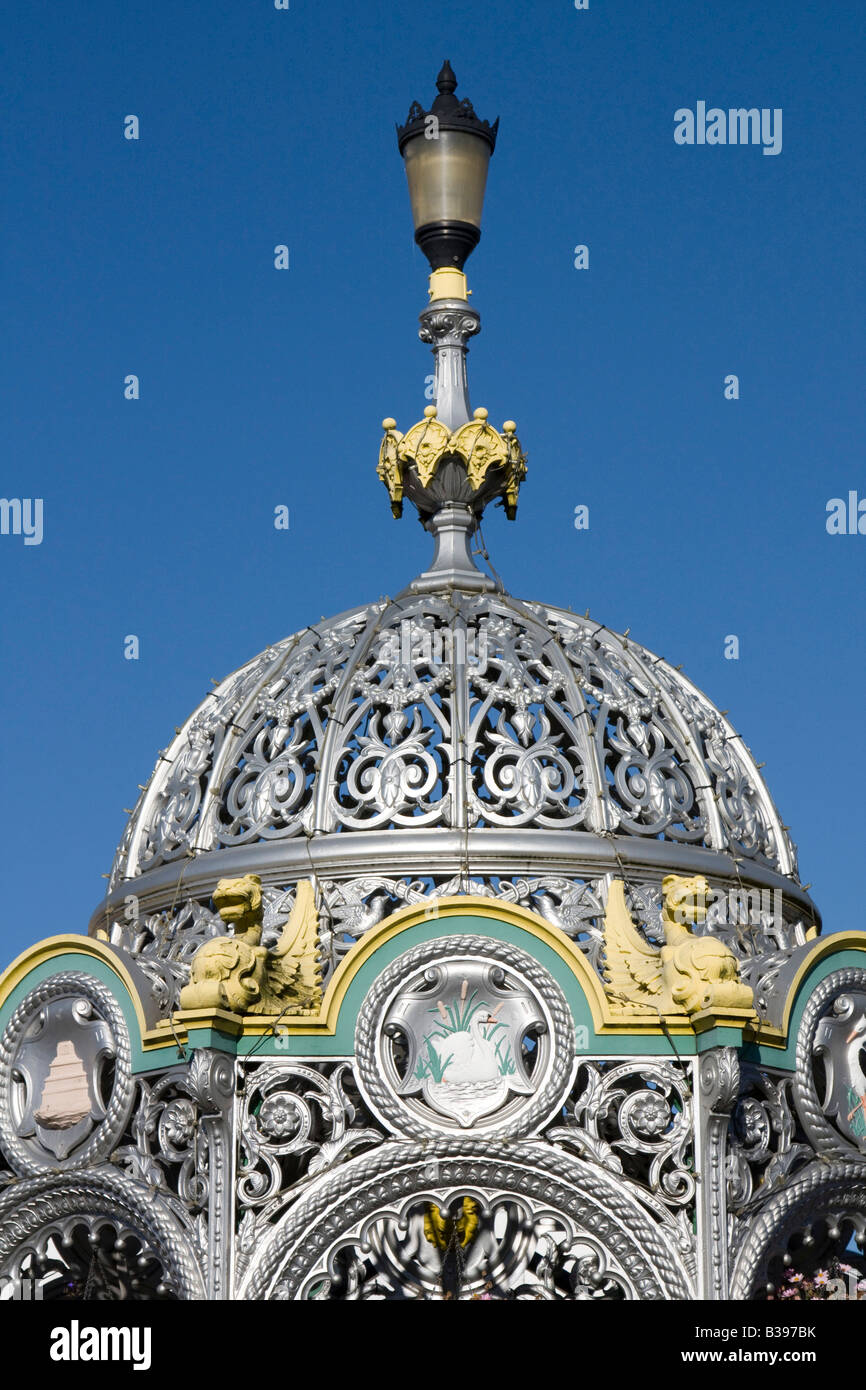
[0,0,866,959]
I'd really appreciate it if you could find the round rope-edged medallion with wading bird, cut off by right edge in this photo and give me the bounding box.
[794,967,866,1159]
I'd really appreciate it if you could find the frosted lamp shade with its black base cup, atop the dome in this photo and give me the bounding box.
[403,129,491,270]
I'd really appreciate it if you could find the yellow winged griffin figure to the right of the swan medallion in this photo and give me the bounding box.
[605,874,753,1015]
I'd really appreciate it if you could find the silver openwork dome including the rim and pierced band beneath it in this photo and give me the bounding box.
[90,566,817,1011]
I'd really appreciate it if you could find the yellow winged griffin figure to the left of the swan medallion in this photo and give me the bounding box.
[181,873,321,1015]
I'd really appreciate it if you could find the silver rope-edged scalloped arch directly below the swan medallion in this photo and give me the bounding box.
[239,1138,691,1300]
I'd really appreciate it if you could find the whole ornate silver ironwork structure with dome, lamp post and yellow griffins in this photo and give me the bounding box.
[0,54,866,1301]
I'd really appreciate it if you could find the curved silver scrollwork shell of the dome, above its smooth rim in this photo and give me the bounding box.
[113,592,796,884]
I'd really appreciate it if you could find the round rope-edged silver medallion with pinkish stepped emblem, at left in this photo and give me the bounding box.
[0,970,133,1176]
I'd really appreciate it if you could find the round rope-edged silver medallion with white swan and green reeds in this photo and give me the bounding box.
[354,935,574,1138]
